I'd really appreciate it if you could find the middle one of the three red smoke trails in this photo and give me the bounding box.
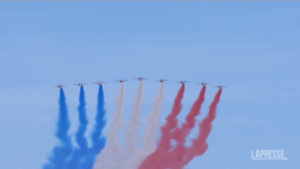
[165,85,206,168]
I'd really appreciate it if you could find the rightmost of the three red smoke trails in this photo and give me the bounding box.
[174,89,222,168]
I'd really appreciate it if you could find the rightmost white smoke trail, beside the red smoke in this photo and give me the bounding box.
[124,83,164,169]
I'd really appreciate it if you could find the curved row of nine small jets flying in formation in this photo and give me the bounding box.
[53,77,227,89]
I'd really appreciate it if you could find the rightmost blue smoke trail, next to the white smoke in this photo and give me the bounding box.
[80,85,106,169]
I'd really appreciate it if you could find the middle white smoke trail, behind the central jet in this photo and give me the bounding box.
[114,81,143,168]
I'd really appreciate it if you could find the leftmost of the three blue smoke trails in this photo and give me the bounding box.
[43,89,72,169]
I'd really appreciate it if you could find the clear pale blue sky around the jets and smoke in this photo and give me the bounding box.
[0,2,300,169]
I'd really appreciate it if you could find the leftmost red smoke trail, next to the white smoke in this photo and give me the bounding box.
[139,84,184,169]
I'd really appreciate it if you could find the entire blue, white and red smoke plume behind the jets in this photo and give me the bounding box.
[43,81,222,169]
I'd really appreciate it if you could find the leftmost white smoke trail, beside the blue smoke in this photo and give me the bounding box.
[93,83,124,169]
